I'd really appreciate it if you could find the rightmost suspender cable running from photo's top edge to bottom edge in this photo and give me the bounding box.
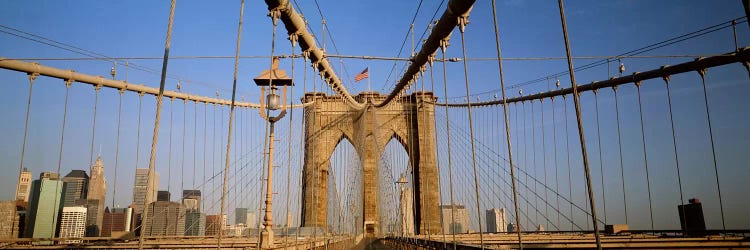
[557,0,602,246]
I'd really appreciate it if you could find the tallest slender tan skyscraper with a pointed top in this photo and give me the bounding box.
[86,155,107,237]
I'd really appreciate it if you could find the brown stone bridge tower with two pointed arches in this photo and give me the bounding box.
[302,92,442,236]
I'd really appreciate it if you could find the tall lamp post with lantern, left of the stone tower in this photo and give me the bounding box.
[253,57,294,248]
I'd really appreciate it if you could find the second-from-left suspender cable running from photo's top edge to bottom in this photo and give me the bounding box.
[220,0,247,249]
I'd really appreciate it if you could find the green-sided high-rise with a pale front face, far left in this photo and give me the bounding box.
[24,172,63,240]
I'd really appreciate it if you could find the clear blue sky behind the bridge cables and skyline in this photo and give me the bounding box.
[0,1,750,242]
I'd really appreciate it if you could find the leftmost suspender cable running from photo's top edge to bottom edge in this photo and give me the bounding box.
[138,0,176,249]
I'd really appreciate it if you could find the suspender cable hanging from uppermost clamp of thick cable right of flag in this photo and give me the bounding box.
[458,15,484,249]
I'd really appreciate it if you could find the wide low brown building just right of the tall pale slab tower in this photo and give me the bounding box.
[141,201,185,236]
